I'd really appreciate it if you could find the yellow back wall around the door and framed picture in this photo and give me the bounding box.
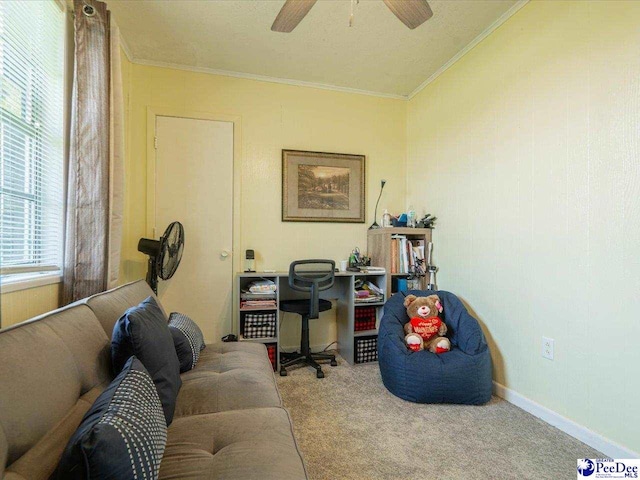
[123,64,406,346]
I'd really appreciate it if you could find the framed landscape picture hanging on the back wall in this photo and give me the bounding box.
[282,150,365,223]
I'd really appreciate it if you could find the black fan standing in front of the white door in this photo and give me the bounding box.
[138,222,184,295]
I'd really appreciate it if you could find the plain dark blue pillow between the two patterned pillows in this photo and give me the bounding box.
[111,297,182,426]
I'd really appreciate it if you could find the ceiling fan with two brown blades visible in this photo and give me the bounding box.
[271,0,433,33]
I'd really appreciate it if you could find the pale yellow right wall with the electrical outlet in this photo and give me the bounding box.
[407,1,640,451]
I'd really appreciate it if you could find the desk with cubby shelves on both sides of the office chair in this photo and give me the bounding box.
[235,271,387,369]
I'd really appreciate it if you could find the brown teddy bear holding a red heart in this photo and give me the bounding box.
[404,295,451,353]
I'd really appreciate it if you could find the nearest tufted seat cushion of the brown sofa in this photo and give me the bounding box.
[160,408,308,480]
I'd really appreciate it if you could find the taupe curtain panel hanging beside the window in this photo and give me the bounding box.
[63,0,124,303]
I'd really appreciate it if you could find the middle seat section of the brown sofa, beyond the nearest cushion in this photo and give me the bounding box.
[175,369,282,417]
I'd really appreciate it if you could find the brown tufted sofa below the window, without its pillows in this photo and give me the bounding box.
[0,280,308,480]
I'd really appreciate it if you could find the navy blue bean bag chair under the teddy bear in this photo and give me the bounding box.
[378,290,492,405]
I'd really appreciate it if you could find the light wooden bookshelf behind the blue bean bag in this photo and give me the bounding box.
[367,227,432,298]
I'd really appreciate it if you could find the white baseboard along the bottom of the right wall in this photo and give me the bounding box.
[493,382,640,458]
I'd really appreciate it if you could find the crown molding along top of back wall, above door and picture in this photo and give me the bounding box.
[131,57,407,100]
